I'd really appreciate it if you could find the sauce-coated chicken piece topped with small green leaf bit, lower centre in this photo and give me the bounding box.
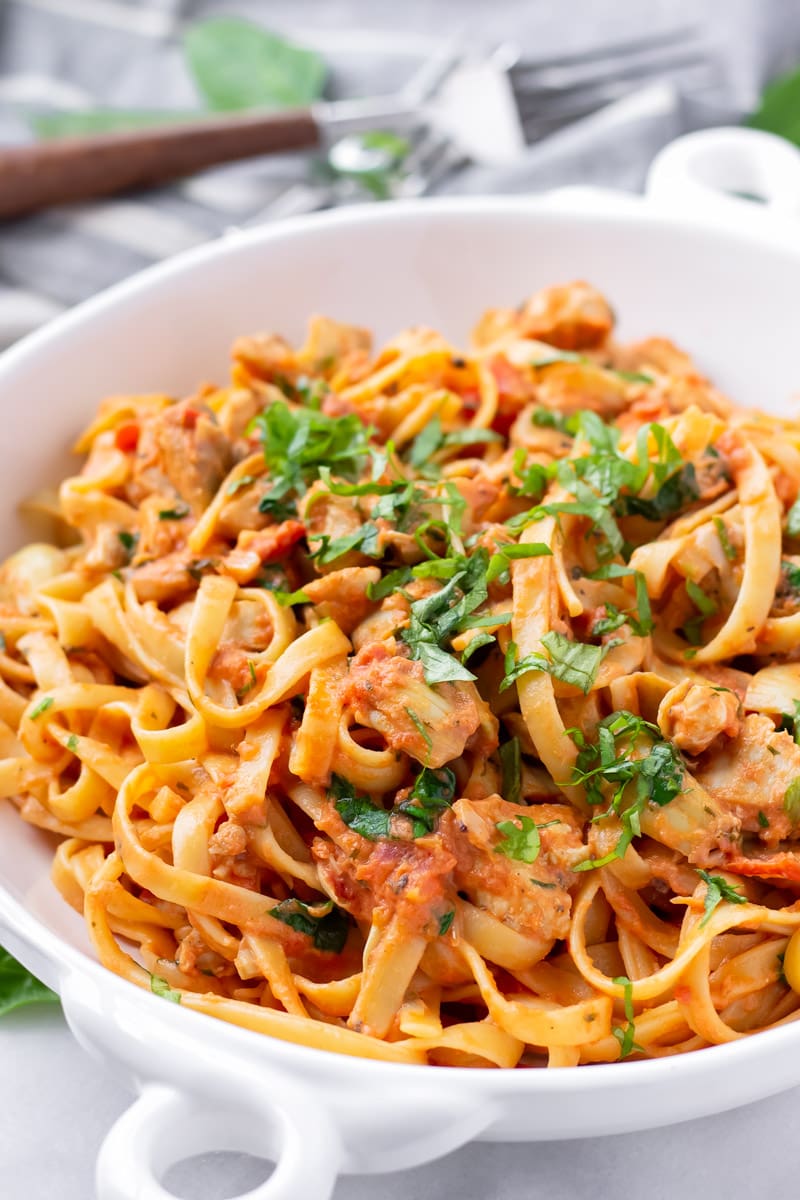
[440,796,588,943]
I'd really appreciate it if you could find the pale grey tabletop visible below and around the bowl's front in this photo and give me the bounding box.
[6,1008,800,1200]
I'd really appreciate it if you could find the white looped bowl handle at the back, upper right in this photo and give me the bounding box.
[646,127,800,235]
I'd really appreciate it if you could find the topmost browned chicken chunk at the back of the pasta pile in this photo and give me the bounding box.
[519,281,614,350]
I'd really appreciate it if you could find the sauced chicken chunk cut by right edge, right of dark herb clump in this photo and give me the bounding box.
[694,713,800,846]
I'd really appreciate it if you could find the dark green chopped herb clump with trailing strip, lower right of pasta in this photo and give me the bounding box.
[567,710,684,871]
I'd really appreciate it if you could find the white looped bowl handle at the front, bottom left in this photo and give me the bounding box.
[96,1079,342,1200]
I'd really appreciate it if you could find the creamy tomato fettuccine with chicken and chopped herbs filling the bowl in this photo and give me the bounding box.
[0,283,800,1069]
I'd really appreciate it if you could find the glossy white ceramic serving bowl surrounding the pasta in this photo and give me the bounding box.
[0,126,800,1200]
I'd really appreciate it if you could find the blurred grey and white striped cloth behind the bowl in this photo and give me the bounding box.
[0,0,800,346]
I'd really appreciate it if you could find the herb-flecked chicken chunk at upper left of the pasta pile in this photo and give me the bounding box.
[127,398,233,516]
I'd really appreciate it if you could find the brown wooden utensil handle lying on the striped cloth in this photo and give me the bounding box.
[0,108,319,217]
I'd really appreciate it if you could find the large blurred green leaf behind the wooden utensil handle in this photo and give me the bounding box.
[184,17,326,110]
